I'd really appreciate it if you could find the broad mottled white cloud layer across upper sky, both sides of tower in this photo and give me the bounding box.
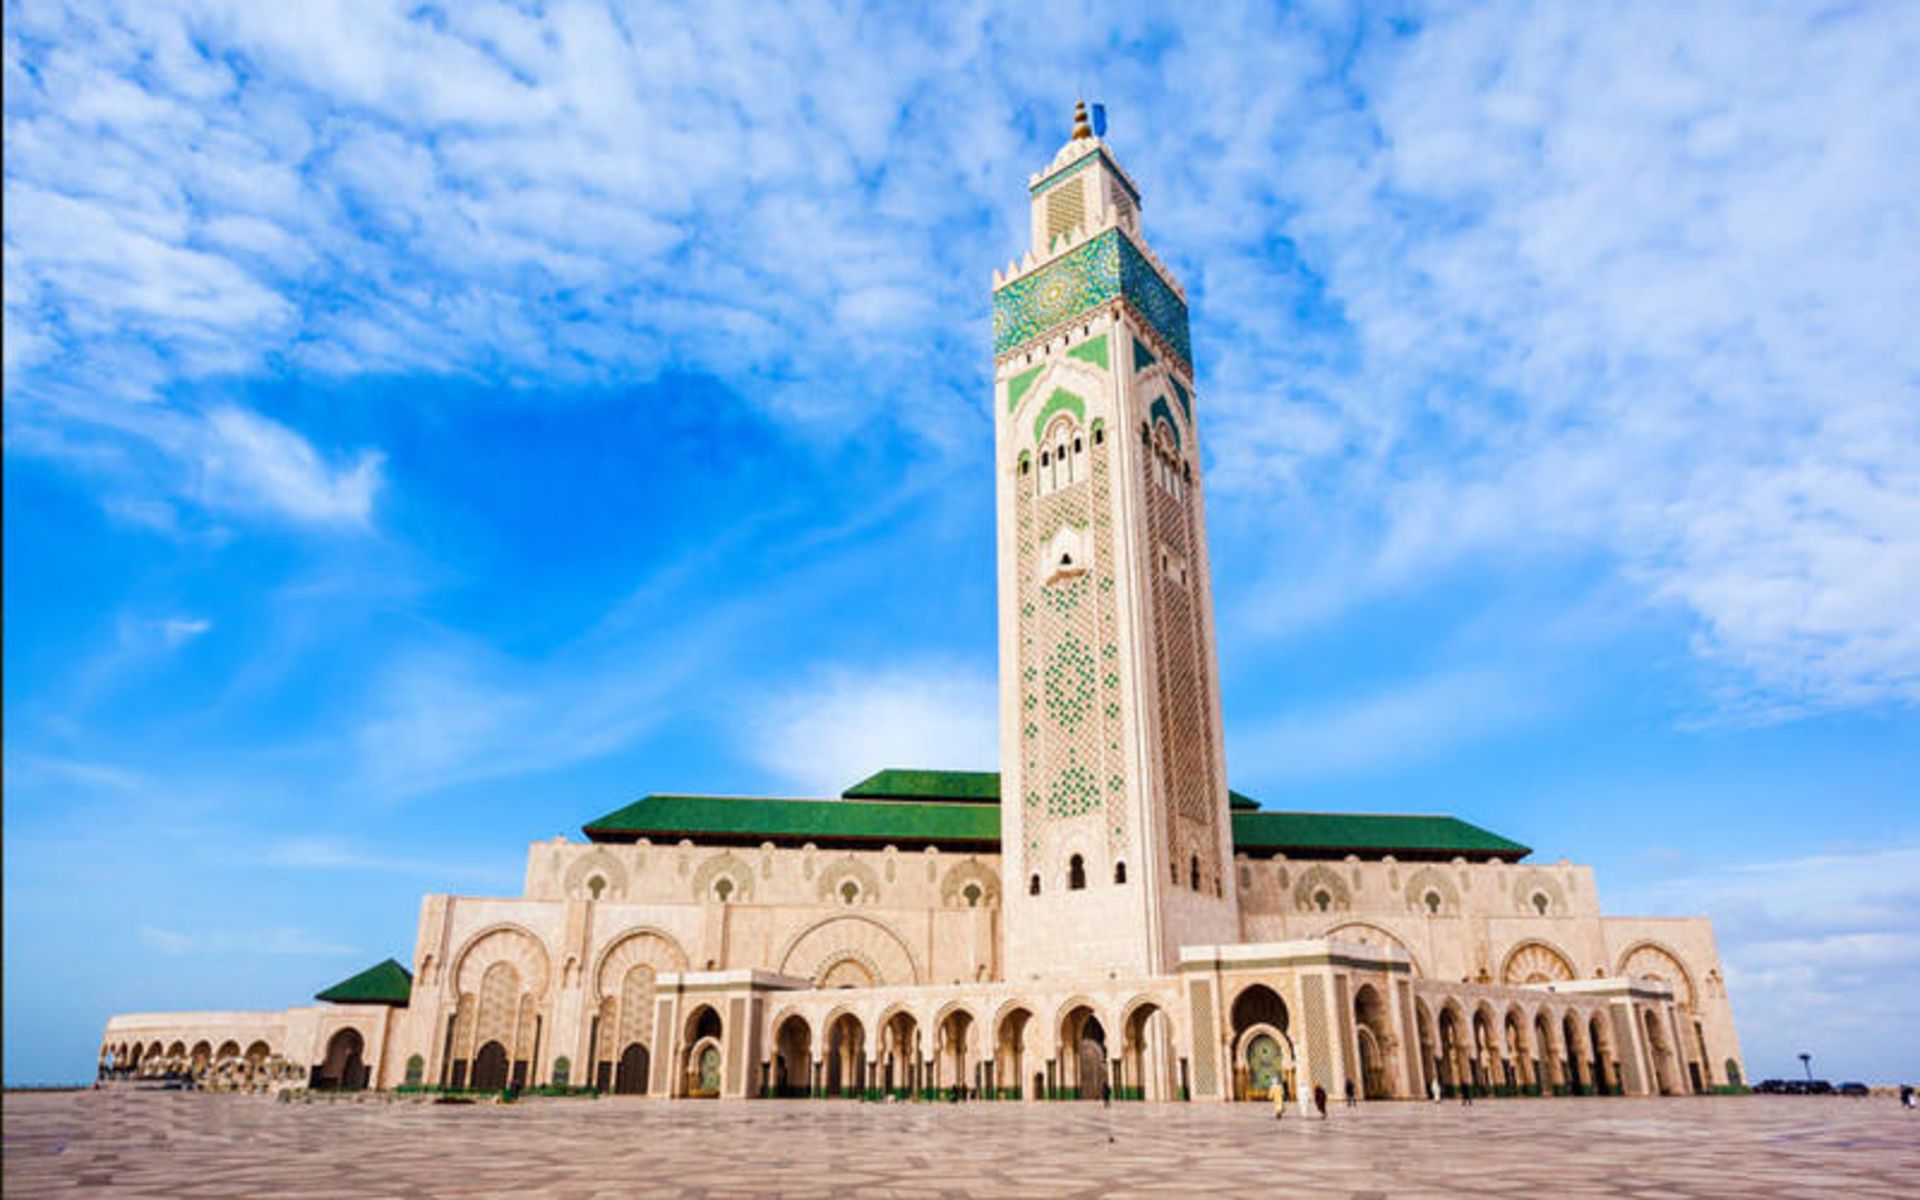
[4,0,1920,716]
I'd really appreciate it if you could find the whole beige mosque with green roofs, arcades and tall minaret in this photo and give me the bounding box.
[100,109,1741,1102]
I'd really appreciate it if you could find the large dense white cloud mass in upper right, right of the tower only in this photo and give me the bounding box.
[1190,4,1920,716]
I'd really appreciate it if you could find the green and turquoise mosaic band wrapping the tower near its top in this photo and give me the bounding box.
[993,228,1192,363]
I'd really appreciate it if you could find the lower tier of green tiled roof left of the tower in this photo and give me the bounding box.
[584,795,1000,851]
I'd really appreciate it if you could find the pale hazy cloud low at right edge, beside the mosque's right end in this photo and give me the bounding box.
[1628,845,1920,1081]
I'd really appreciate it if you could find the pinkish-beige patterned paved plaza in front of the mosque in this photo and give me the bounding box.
[4,1092,1920,1200]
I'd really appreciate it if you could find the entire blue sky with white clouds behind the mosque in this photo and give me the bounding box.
[4,0,1920,1083]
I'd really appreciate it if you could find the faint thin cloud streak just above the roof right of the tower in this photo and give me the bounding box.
[1227,672,1548,780]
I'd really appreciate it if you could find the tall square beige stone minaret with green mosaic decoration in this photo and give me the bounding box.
[993,108,1240,979]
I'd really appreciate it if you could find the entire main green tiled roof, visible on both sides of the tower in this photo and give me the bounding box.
[583,770,1532,856]
